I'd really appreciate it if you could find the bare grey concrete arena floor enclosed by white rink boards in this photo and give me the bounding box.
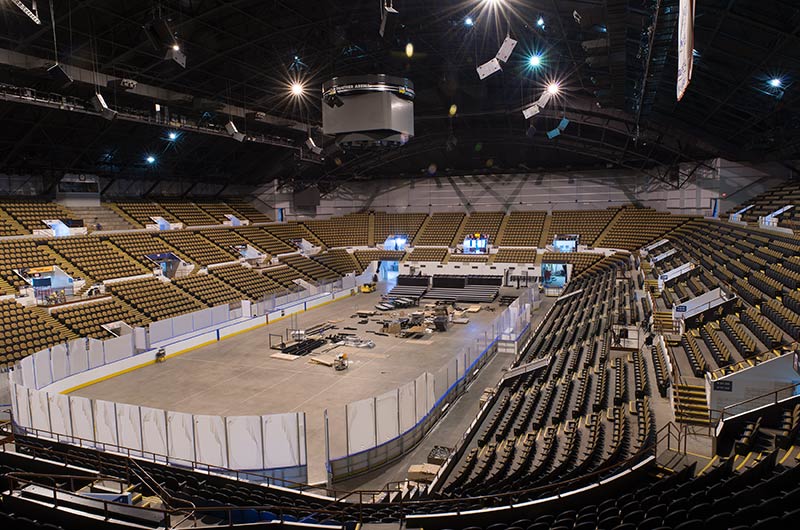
[69,283,520,483]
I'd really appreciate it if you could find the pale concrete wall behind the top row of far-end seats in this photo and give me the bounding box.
[257,159,786,220]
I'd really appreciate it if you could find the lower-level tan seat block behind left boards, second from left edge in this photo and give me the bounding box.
[50,298,150,339]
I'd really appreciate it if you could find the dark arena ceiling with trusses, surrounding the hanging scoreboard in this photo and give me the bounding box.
[0,0,800,190]
